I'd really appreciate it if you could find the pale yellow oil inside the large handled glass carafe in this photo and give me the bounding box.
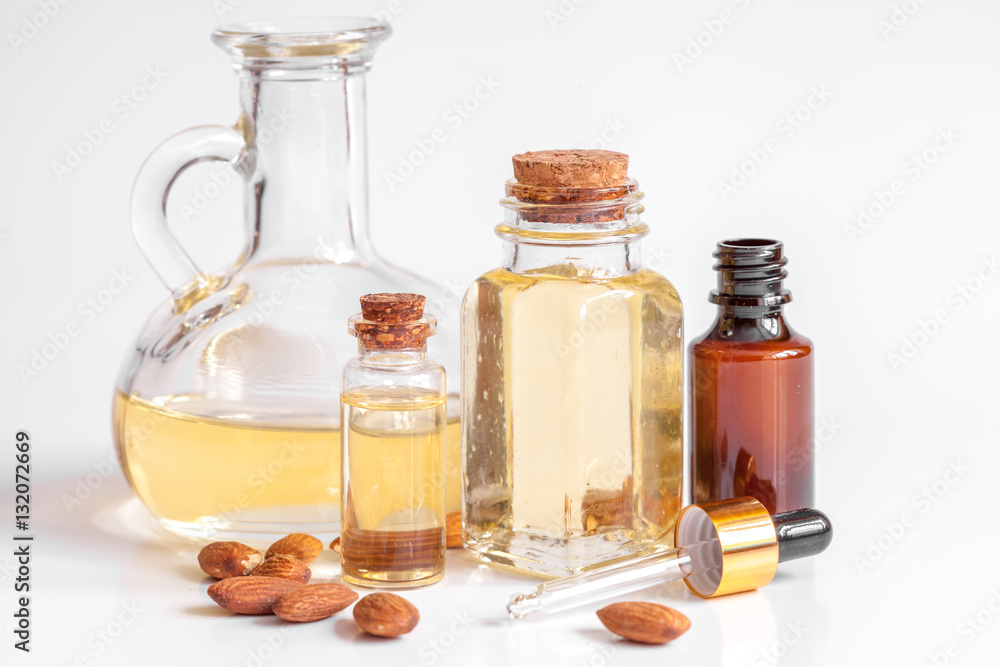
[113,391,461,538]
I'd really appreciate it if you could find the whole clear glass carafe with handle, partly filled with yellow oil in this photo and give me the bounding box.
[114,19,460,539]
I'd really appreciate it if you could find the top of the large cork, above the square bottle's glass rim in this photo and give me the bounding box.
[513,150,628,188]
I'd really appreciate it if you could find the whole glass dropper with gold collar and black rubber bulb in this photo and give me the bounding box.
[507,498,833,618]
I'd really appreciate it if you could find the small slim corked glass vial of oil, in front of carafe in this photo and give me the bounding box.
[340,294,447,588]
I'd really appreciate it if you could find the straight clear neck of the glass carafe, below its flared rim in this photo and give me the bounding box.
[240,68,372,263]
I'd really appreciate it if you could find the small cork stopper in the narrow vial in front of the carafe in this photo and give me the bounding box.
[348,292,437,349]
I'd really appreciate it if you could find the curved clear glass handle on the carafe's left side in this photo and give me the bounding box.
[131,125,247,310]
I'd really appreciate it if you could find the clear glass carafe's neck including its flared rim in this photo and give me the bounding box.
[212,17,391,270]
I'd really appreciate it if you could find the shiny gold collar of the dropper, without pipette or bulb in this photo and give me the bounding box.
[674,497,778,598]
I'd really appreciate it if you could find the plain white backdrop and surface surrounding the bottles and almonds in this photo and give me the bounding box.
[0,0,1000,665]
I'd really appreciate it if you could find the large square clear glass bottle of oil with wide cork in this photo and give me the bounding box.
[462,150,683,576]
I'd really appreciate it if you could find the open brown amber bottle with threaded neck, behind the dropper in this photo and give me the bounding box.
[690,239,813,514]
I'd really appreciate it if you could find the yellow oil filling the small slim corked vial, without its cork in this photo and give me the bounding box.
[340,387,447,587]
